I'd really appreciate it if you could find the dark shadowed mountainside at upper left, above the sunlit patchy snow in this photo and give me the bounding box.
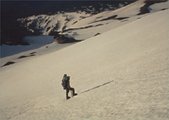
[0,0,133,45]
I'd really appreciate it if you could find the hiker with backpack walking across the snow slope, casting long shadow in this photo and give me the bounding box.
[62,74,77,99]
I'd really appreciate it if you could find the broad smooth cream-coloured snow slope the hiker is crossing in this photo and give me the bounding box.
[0,6,169,120]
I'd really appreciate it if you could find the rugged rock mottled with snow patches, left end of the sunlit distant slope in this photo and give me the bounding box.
[18,12,90,35]
